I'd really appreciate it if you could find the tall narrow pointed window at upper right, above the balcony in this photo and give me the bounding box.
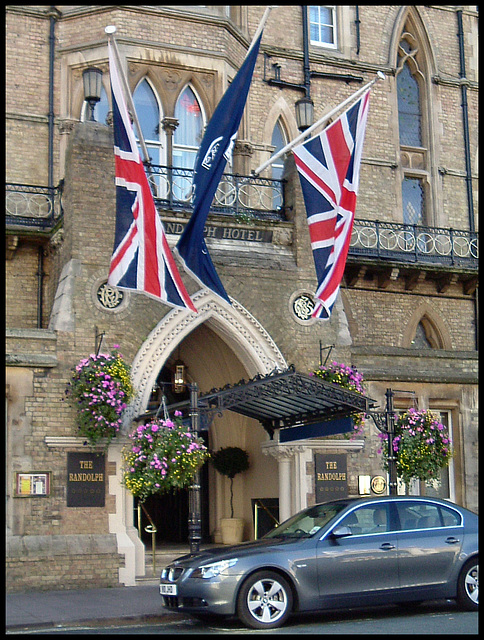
[396,19,432,225]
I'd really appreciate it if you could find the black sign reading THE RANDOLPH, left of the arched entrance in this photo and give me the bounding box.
[67,452,106,507]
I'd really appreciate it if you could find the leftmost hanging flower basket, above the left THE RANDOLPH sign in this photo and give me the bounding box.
[66,345,134,446]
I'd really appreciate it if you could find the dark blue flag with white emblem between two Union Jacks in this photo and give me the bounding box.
[175,33,262,304]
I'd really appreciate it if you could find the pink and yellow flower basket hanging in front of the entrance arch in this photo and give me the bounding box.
[122,411,210,502]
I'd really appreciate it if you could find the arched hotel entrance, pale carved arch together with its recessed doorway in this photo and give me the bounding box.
[125,291,287,544]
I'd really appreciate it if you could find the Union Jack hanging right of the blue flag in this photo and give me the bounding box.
[293,90,370,320]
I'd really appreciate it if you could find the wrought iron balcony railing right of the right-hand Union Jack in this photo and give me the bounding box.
[348,220,479,269]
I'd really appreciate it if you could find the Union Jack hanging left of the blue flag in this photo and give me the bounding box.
[108,42,197,313]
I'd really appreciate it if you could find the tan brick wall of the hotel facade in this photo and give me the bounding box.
[6,6,478,590]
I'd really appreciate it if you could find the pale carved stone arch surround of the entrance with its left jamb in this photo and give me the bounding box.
[109,290,287,585]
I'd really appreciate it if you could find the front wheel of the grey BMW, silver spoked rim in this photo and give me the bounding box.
[237,571,293,629]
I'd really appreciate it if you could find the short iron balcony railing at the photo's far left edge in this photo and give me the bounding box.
[5,183,63,231]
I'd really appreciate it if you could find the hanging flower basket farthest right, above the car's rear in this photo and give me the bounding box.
[378,408,452,485]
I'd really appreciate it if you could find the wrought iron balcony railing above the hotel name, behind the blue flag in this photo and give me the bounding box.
[147,165,286,220]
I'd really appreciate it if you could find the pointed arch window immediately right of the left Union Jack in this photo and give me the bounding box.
[133,78,164,165]
